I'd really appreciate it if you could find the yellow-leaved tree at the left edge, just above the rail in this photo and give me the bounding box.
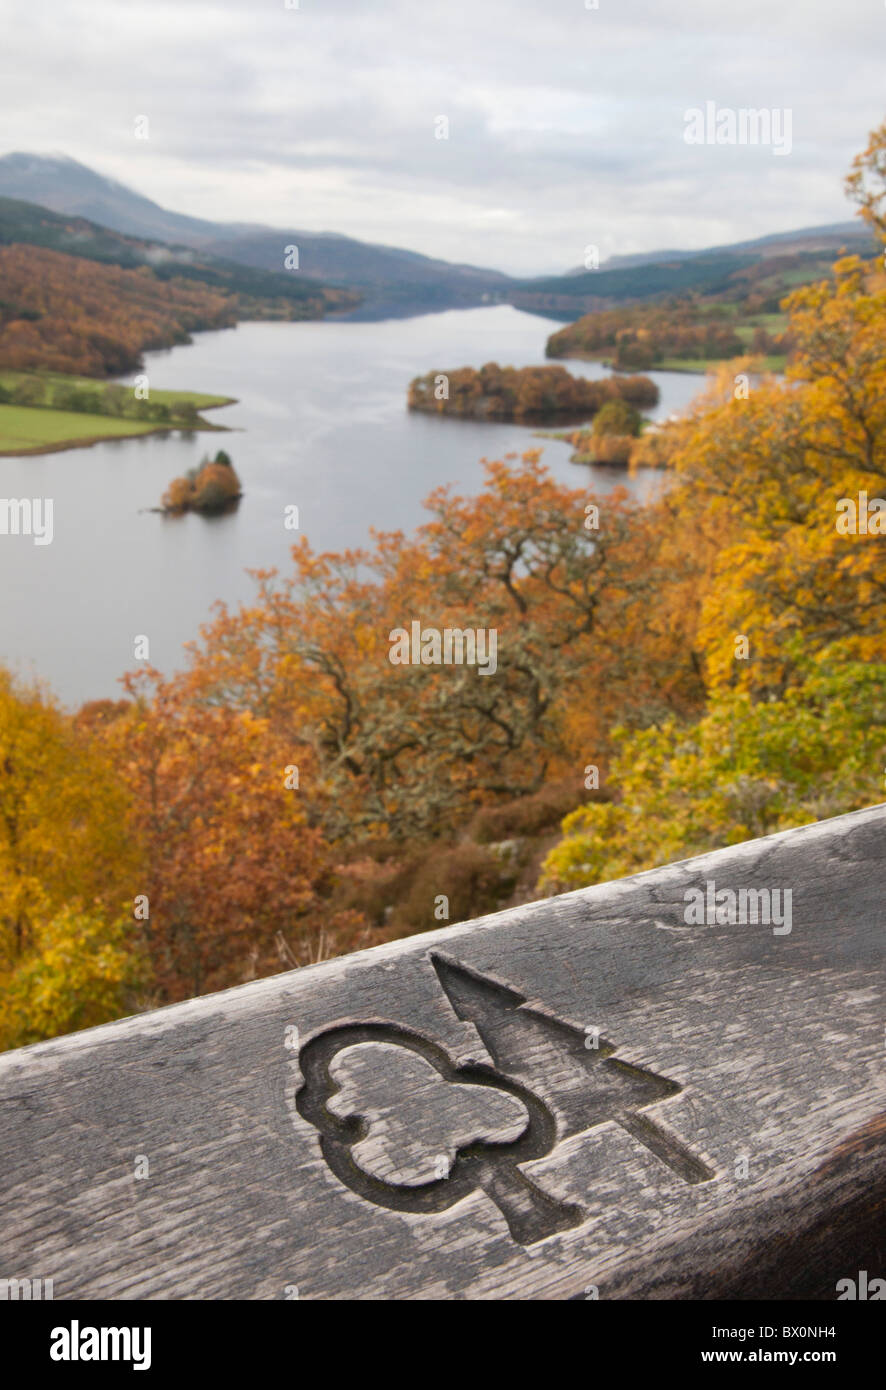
[0,670,142,1047]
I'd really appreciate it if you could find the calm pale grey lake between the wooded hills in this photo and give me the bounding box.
[0,304,702,706]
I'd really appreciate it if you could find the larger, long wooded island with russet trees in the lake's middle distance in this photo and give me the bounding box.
[408,361,658,424]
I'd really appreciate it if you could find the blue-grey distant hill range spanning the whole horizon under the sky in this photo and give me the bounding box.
[0,154,873,320]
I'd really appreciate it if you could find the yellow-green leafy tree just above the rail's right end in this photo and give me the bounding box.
[538,648,886,892]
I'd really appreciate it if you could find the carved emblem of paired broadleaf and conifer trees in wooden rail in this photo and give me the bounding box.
[296,955,714,1245]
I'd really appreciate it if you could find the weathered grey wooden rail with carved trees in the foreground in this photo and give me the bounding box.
[0,806,886,1300]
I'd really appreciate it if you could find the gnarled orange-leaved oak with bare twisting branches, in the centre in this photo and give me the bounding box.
[157,453,698,838]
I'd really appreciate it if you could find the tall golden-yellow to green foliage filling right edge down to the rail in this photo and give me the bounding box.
[542,128,886,891]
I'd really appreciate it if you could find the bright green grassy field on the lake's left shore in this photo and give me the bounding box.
[0,368,232,456]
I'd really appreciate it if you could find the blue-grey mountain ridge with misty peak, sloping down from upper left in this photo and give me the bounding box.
[0,154,515,309]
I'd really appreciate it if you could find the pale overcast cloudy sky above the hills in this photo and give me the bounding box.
[0,0,886,274]
